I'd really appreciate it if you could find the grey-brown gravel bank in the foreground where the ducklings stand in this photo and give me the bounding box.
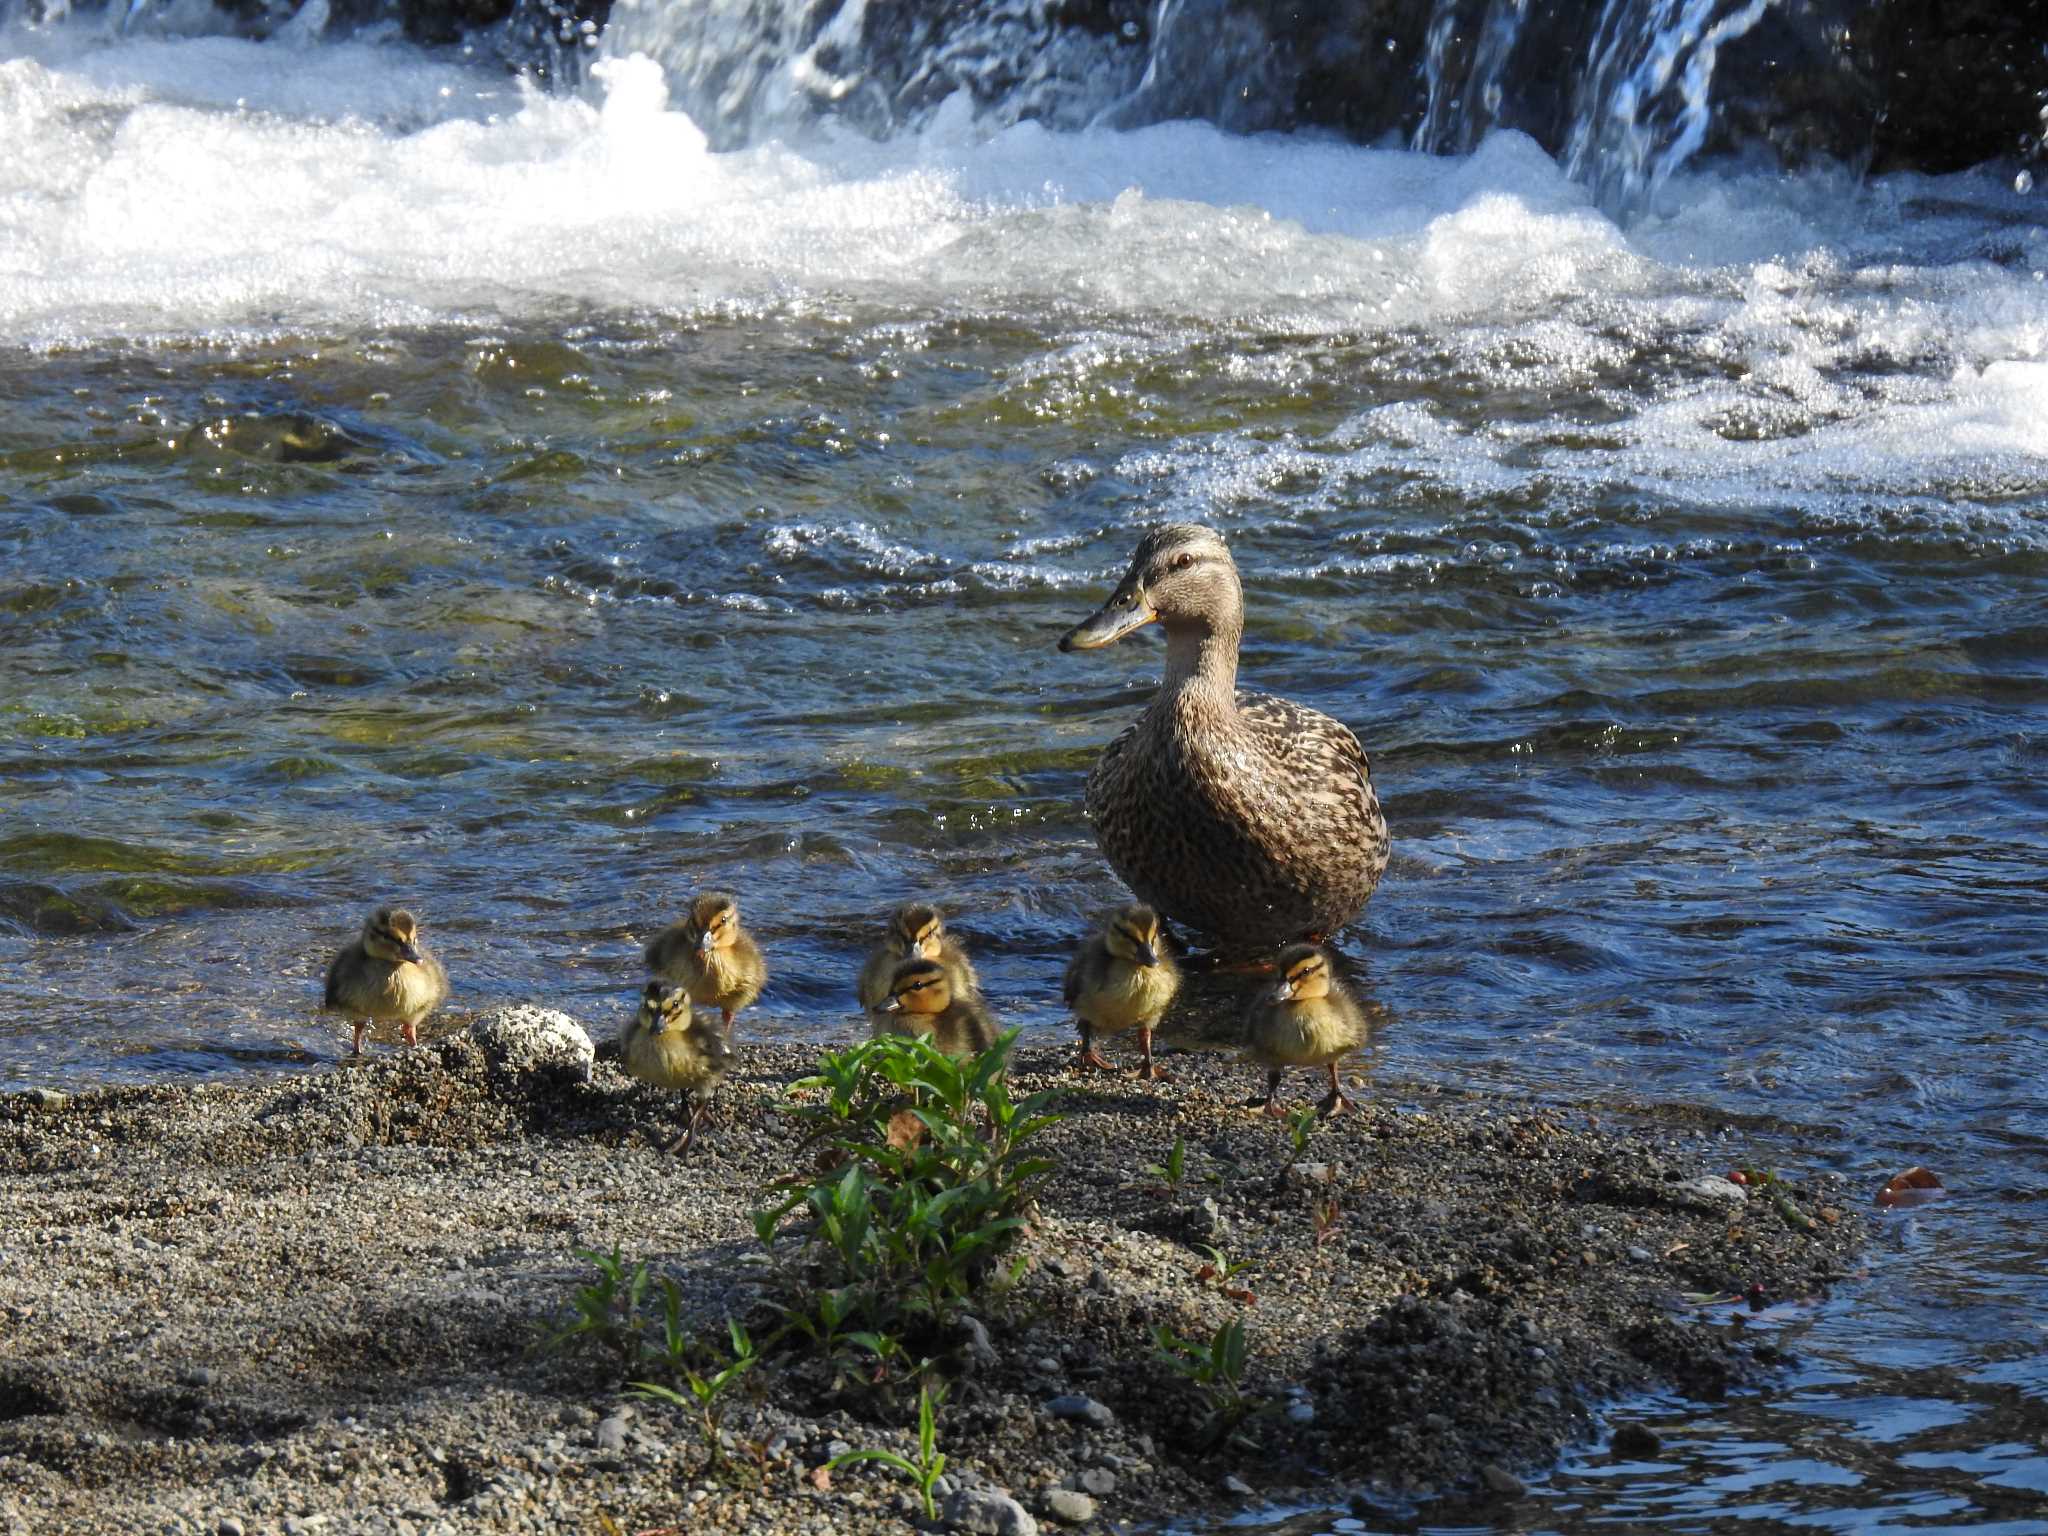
[0,1011,1860,1536]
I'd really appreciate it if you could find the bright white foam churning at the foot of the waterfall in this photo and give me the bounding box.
[0,33,2048,512]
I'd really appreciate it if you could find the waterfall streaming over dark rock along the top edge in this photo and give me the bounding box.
[0,0,1982,219]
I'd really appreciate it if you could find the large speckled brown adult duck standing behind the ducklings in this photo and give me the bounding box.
[1059,522,1386,948]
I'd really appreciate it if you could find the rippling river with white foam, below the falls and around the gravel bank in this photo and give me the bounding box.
[0,6,2048,1534]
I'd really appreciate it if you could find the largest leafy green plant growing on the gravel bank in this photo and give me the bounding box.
[754,1032,1059,1364]
